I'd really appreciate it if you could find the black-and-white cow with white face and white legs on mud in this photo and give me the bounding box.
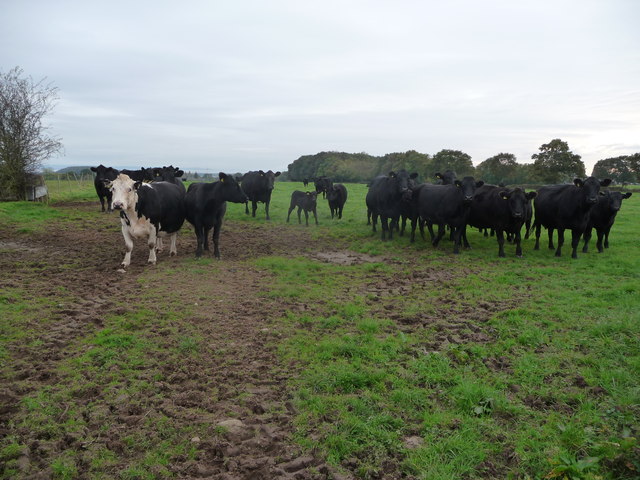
[109,173,185,268]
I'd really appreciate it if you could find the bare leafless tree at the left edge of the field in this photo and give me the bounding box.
[0,67,62,200]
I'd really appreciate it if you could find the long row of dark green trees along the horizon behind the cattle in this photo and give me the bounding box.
[287,139,640,185]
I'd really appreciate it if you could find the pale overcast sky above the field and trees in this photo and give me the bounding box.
[0,0,640,173]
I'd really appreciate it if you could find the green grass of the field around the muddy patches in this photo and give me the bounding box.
[0,178,640,480]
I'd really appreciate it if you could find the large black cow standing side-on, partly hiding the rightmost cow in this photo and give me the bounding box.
[533,177,611,258]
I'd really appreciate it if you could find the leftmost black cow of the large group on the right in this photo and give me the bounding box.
[366,169,418,240]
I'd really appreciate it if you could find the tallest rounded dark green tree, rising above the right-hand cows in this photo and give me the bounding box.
[531,138,586,183]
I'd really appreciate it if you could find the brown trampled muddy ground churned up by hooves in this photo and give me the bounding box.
[0,203,506,479]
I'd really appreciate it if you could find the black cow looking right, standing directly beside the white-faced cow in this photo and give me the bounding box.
[184,172,247,259]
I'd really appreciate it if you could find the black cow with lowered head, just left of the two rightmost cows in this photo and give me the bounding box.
[462,185,536,257]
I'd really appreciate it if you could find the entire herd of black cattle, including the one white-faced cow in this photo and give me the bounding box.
[91,165,631,268]
